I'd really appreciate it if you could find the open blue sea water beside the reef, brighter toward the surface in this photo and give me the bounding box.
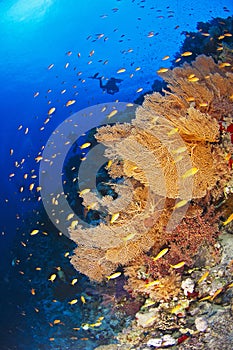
[0,0,233,350]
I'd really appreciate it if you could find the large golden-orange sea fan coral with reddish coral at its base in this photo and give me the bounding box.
[70,55,233,300]
